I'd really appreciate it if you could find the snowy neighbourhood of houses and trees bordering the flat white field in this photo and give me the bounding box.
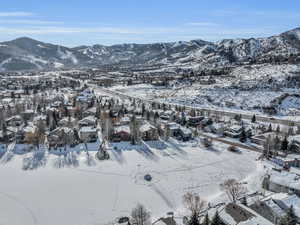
[0,70,300,225]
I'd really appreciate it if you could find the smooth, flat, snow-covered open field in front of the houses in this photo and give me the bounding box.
[0,139,259,225]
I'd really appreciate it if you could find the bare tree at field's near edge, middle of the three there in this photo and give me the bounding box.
[183,192,206,217]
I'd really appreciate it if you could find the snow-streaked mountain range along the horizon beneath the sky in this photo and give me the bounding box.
[0,28,300,71]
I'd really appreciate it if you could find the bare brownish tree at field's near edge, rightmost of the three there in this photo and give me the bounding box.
[221,179,246,202]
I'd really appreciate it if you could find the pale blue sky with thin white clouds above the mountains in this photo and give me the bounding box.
[0,0,300,46]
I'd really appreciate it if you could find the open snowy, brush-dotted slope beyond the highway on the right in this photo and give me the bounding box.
[111,62,300,116]
